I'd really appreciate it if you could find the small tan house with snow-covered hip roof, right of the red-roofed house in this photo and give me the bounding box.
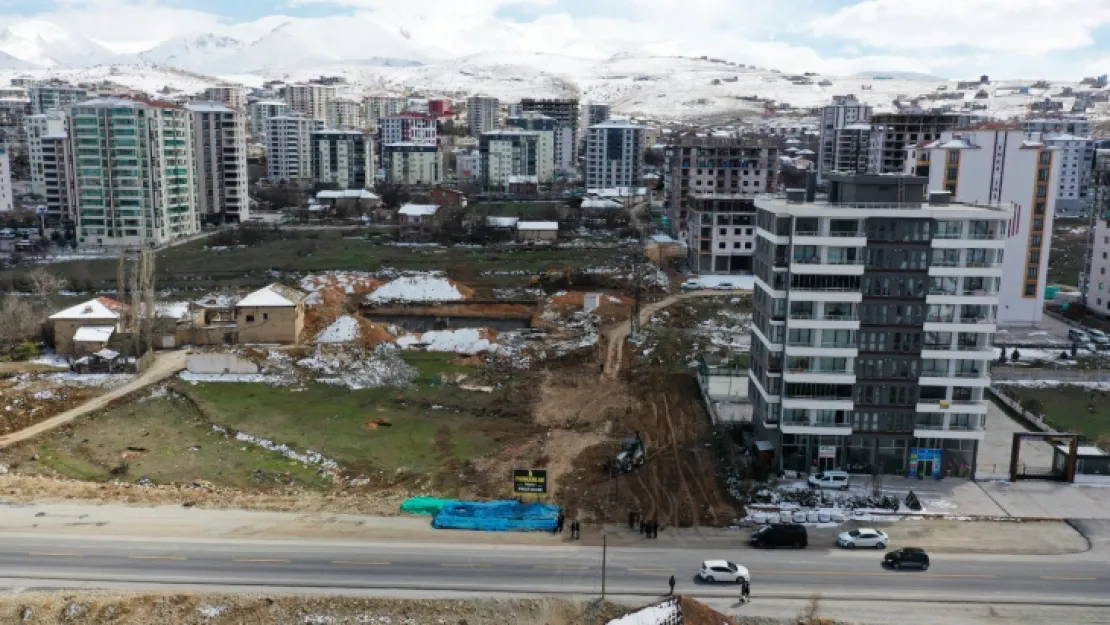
[235,283,305,344]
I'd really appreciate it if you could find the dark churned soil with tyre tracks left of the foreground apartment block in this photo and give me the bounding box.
[552,374,743,527]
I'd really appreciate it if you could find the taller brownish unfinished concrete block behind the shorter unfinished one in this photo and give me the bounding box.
[664,134,779,243]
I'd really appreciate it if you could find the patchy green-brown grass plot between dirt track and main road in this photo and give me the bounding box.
[12,353,539,494]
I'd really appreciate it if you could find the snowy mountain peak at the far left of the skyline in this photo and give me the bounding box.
[0,20,118,68]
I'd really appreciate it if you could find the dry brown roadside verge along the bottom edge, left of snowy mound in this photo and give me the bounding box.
[0,591,634,625]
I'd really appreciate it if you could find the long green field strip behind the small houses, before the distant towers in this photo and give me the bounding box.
[0,231,619,292]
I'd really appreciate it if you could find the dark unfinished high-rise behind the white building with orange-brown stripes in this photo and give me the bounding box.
[865,112,972,173]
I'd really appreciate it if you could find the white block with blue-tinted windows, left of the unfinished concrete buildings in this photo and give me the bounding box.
[586,120,647,189]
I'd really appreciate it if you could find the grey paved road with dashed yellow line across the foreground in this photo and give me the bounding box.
[0,534,1110,605]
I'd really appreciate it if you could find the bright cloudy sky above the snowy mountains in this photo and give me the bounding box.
[8,0,1110,79]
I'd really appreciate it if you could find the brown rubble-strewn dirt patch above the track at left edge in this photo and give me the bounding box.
[0,375,107,434]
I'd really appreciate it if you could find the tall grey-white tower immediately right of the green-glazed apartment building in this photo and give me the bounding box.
[185,102,251,223]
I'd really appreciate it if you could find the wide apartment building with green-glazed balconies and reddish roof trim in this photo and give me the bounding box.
[67,98,200,249]
